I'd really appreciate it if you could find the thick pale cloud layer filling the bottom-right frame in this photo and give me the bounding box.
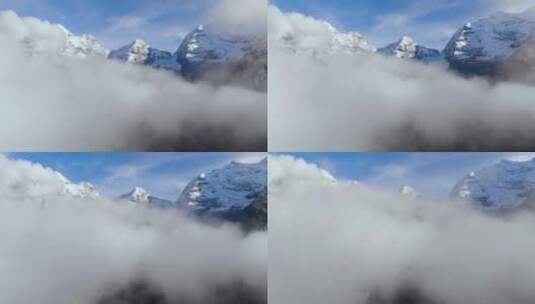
[269,156,535,304]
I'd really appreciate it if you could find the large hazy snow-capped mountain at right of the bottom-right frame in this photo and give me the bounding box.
[451,159,535,211]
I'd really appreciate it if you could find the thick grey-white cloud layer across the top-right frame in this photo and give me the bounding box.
[268,7,535,151]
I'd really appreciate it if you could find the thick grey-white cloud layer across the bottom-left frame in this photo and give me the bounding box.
[0,157,267,304]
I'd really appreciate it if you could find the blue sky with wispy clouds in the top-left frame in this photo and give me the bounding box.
[0,0,218,51]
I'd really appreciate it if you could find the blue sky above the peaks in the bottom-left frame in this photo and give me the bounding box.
[8,153,265,200]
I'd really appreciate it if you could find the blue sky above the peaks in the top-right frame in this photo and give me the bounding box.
[271,0,535,49]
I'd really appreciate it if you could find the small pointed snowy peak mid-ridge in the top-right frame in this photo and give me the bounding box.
[378,36,442,62]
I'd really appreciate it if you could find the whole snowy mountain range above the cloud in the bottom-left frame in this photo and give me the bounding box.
[26,159,267,231]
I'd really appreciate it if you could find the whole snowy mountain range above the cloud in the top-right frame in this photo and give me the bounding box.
[278,8,535,78]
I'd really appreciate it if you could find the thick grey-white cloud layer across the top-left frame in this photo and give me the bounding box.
[0,12,267,151]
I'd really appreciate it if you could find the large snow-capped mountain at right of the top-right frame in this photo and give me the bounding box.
[444,9,535,75]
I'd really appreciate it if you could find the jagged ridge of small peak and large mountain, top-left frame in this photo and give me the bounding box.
[109,26,267,91]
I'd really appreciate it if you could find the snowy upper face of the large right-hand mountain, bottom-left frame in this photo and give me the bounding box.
[177,159,267,214]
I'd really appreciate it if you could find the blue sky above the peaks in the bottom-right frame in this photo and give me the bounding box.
[282,153,535,198]
